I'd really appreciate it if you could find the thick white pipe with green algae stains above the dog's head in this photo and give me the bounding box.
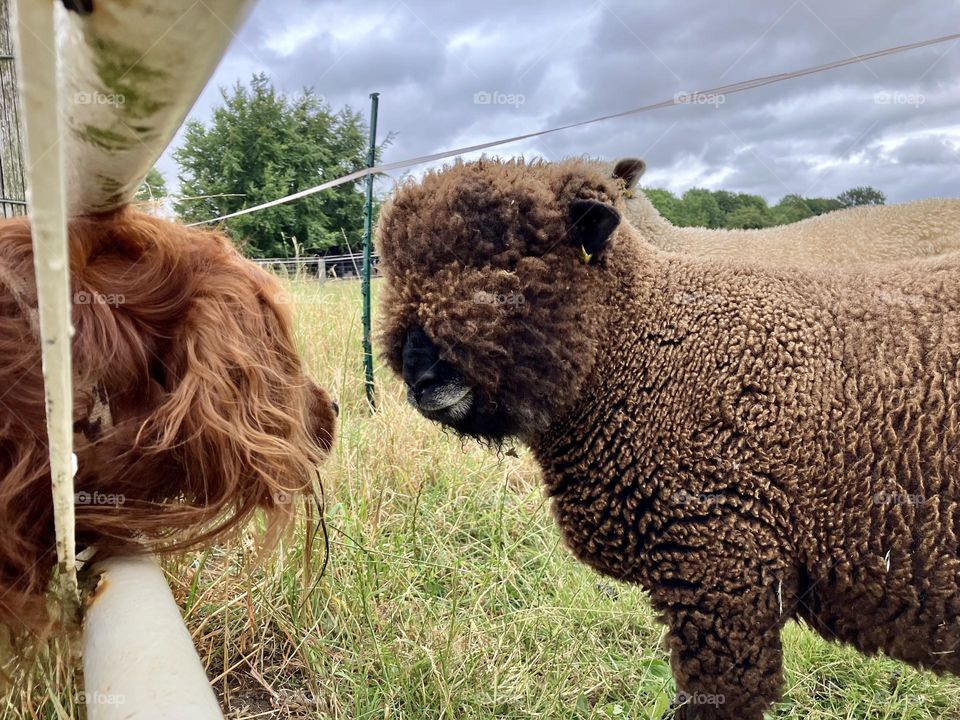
[56,0,253,215]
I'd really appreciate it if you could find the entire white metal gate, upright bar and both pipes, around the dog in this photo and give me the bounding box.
[16,0,252,720]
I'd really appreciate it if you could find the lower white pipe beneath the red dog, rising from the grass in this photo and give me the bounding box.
[81,555,223,720]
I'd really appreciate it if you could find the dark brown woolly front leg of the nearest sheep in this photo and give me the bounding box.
[652,556,784,720]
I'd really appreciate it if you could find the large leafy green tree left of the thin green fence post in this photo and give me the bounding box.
[174,74,383,257]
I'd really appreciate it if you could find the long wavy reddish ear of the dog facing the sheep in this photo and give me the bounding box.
[142,236,326,544]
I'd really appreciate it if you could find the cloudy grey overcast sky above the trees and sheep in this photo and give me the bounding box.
[159,0,960,207]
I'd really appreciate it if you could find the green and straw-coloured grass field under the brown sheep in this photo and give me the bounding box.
[2,281,960,720]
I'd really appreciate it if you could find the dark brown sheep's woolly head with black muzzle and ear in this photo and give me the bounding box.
[377,161,619,441]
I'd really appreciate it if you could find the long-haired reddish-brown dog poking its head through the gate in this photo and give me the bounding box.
[0,209,336,629]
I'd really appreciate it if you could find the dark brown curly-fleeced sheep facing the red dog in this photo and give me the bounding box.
[378,160,960,720]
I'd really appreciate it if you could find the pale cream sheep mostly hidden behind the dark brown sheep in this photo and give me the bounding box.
[596,158,960,265]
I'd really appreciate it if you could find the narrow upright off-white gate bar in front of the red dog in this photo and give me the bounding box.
[14,0,79,618]
